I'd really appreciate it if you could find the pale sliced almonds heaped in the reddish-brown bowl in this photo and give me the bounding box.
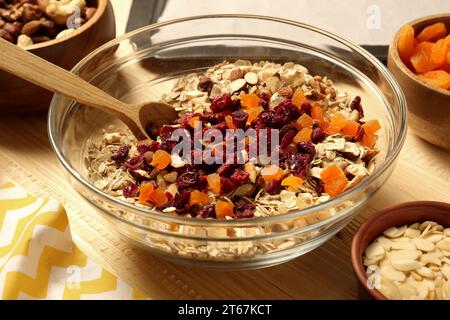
[363,221,450,299]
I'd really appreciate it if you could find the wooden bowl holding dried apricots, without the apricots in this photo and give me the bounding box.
[388,13,450,149]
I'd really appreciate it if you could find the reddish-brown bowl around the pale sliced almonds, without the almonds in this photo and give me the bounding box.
[351,201,450,300]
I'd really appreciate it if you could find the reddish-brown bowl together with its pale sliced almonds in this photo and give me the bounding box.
[351,201,450,300]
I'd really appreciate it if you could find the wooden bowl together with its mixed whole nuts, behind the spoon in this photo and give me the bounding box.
[0,0,116,114]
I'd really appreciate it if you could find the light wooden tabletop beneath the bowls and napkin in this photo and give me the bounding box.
[0,0,450,299]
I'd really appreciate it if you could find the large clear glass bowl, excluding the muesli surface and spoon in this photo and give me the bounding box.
[48,15,406,269]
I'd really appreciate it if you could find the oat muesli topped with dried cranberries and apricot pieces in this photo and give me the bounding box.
[85,60,380,219]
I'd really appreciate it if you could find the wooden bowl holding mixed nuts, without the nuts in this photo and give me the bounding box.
[0,0,116,114]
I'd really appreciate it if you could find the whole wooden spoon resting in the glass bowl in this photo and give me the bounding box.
[0,38,178,139]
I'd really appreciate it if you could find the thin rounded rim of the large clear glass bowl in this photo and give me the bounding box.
[47,14,407,227]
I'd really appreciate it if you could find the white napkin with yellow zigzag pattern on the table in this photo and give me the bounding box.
[0,179,146,299]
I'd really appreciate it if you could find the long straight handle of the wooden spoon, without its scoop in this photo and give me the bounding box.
[0,38,131,120]
